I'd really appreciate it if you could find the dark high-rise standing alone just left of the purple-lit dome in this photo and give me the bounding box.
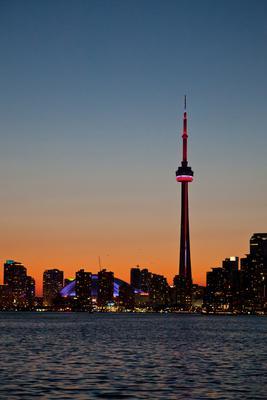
[43,269,64,306]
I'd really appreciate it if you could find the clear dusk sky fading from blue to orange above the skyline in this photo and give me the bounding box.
[0,0,267,293]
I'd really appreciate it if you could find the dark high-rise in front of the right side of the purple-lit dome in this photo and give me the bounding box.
[97,269,114,307]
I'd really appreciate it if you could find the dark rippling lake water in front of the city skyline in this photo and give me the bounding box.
[0,313,267,400]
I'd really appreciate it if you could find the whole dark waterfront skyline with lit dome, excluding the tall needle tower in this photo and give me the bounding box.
[0,233,267,314]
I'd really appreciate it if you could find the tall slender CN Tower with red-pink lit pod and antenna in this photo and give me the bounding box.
[176,96,194,288]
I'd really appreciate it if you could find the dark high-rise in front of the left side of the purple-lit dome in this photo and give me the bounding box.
[75,269,92,311]
